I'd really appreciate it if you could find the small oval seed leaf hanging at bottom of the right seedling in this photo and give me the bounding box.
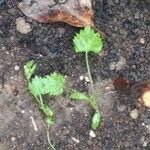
[92,112,101,130]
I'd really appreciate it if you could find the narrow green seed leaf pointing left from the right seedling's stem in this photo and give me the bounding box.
[69,90,90,103]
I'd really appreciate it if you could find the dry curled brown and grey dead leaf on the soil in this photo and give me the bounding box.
[18,0,94,27]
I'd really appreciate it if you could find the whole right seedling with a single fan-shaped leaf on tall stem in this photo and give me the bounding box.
[70,27,103,130]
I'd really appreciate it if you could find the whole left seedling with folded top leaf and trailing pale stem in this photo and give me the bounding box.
[24,61,65,150]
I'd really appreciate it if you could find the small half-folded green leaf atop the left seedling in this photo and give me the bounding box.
[24,60,36,81]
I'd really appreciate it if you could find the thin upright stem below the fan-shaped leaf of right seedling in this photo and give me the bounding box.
[85,52,96,98]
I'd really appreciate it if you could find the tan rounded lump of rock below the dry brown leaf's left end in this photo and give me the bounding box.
[16,17,31,34]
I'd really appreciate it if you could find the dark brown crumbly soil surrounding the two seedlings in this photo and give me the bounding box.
[0,0,150,150]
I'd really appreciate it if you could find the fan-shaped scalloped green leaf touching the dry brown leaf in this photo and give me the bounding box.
[73,26,103,53]
